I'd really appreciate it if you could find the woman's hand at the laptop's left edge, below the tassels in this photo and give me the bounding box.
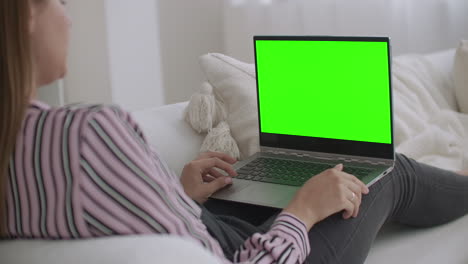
[180,152,237,203]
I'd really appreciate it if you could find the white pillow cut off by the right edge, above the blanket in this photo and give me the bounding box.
[454,40,468,114]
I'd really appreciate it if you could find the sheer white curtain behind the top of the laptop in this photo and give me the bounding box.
[223,0,468,62]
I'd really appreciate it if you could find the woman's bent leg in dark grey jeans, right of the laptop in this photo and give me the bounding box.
[306,154,468,264]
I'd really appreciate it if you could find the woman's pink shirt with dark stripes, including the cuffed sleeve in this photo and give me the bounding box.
[7,101,310,263]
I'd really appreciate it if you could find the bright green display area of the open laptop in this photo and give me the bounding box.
[256,40,392,144]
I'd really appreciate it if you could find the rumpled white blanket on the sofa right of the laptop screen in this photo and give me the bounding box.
[393,55,468,170]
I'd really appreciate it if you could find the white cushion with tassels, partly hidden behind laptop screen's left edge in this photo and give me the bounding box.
[200,53,259,159]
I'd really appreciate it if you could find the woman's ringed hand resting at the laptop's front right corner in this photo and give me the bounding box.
[284,164,369,229]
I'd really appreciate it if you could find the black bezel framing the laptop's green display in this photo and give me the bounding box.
[253,36,395,160]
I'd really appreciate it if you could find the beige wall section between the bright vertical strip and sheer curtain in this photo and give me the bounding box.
[156,0,223,103]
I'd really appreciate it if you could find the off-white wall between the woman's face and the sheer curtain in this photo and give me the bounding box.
[65,0,223,110]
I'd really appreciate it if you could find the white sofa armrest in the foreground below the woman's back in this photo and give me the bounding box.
[0,235,220,264]
